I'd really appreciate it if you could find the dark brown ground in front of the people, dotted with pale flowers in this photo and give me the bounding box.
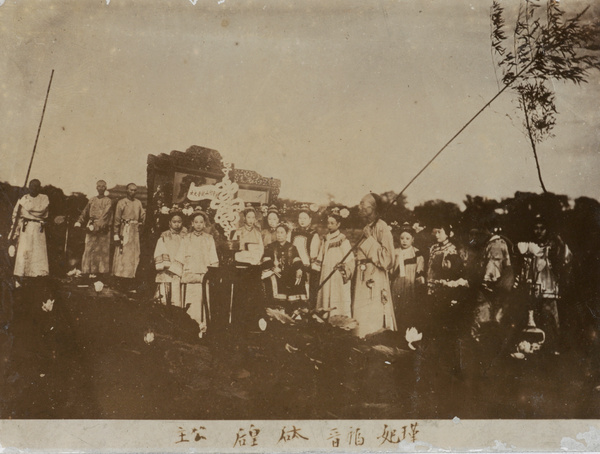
[0,278,600,419]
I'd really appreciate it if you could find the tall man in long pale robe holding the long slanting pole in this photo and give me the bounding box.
[352,194,397,338]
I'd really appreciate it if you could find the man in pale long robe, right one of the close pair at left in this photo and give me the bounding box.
[112,183,146,279]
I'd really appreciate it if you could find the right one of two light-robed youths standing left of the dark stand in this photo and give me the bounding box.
[171,211,219,336]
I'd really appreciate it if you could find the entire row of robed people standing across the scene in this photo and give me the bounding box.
[8,180,570,352]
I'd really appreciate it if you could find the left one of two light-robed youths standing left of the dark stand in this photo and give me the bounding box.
[154,212,187,307]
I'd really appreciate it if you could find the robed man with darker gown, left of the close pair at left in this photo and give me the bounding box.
[75,180,112,274]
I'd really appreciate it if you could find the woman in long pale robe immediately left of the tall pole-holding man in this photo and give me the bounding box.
[316,212,355,317]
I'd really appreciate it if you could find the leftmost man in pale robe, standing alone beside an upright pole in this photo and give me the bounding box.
[13,180,50,277]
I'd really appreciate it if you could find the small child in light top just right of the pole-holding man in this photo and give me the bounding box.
[391,222,425,331]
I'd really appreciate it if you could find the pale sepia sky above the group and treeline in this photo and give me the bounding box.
[0,0,600,205]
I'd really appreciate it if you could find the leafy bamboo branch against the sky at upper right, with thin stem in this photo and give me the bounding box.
[490,0,600,192]
